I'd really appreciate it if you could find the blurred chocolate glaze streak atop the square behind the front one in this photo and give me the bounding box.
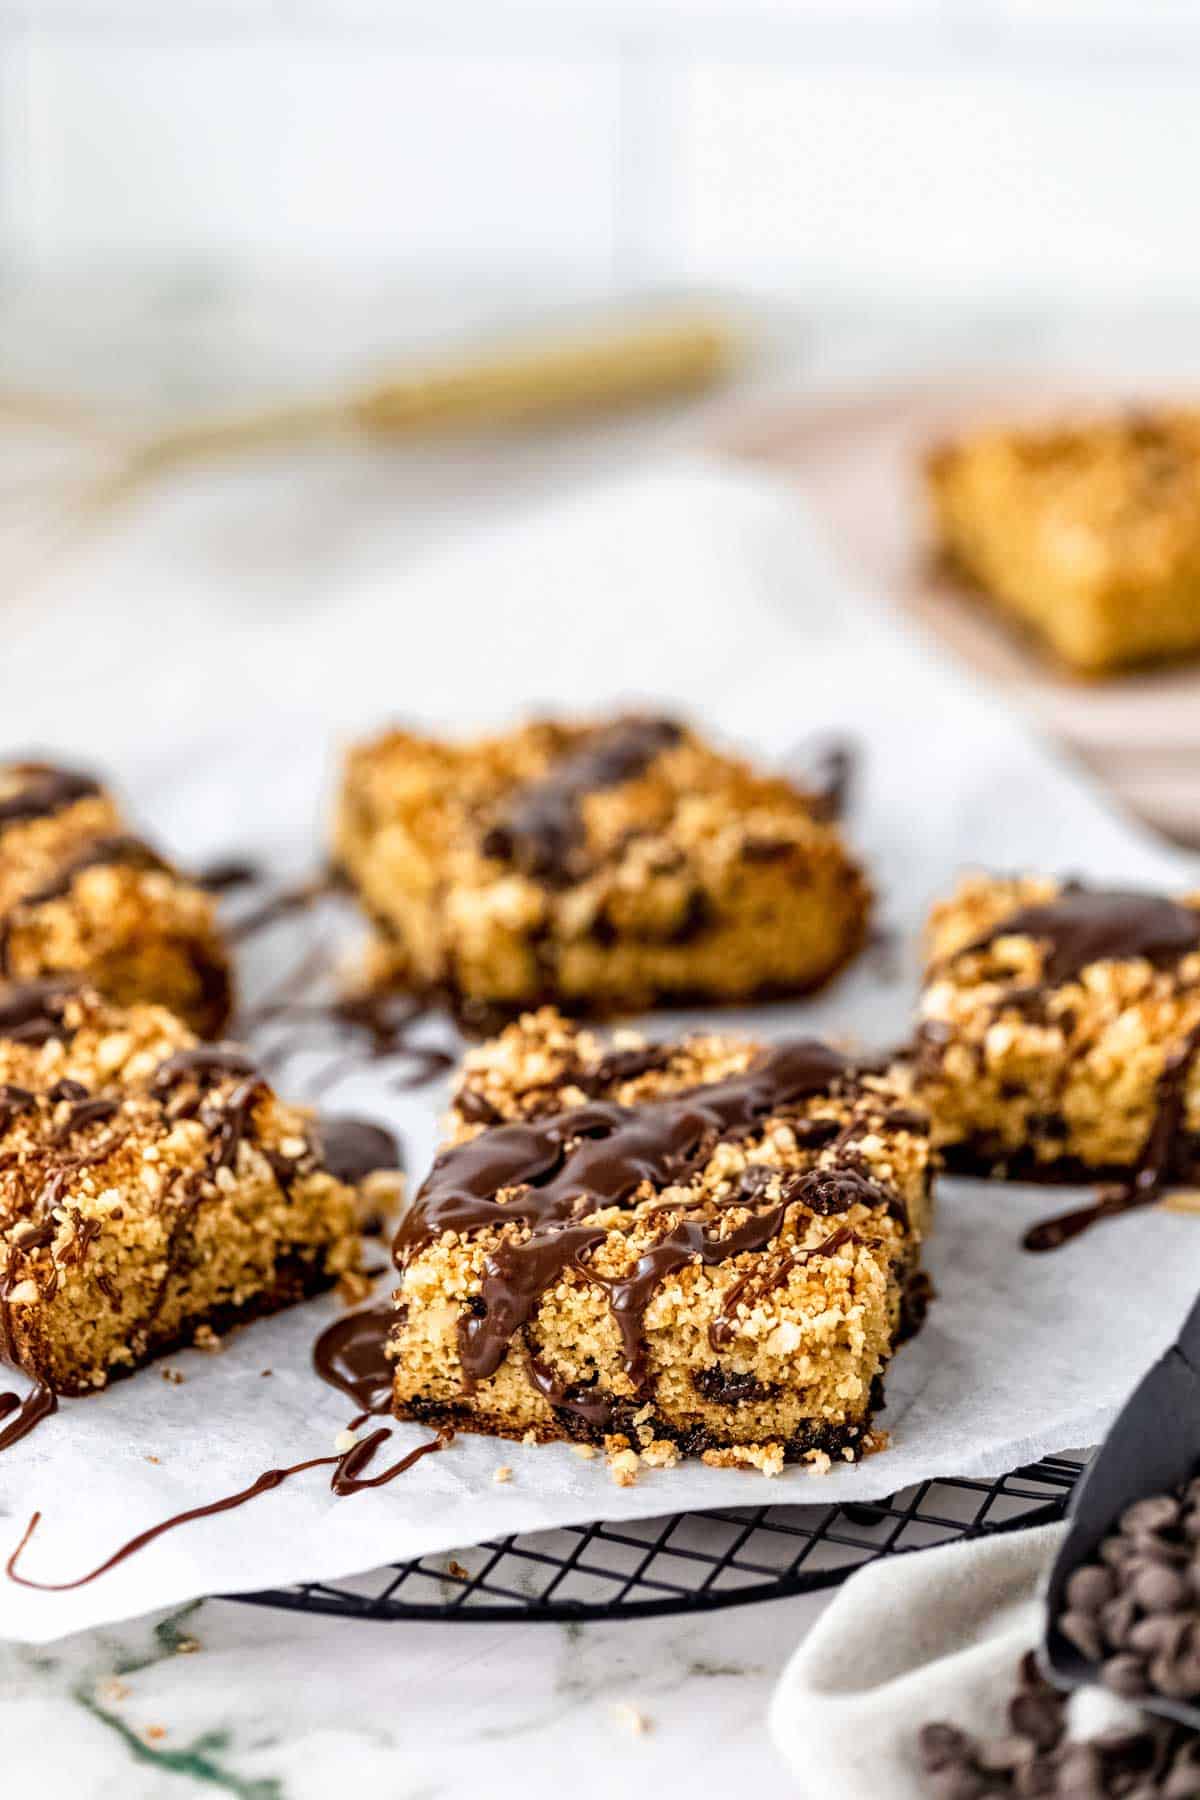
[482,718,684,884]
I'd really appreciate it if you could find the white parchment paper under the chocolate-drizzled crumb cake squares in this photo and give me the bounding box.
[0,463,1200,1642]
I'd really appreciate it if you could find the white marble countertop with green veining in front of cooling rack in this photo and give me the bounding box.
[0,1595,826,1800]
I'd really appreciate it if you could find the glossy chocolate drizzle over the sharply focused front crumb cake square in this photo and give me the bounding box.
[394,1039,896,1408]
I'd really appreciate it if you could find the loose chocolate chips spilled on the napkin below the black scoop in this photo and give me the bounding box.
[918,1652,1200,1800]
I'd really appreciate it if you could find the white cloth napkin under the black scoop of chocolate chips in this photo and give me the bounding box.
[770,1525,1139,1800]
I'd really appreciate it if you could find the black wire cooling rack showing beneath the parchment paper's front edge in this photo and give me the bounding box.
[230,1456,1083,1622]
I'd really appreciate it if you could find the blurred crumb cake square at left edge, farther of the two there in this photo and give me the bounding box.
[0,761,232,1037]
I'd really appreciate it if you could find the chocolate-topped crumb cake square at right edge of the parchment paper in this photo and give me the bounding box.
[918,875,1200,1186]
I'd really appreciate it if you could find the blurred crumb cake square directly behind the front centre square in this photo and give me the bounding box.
[335,716,869,1021]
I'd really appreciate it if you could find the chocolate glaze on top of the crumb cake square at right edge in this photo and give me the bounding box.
[954,884,1200,992]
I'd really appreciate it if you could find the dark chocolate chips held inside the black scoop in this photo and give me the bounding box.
[1058,1478,1200,1699]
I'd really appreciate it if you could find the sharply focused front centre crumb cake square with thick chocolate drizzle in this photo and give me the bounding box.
[390,1008,934,1472]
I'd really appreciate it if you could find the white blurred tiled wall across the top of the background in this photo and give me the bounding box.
[0,0,1200,302]
